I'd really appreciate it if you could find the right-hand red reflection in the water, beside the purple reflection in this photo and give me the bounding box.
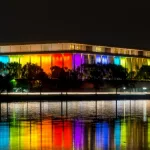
[63,121,73,150]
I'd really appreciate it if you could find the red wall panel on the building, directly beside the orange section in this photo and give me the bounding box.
[52,53,63,68]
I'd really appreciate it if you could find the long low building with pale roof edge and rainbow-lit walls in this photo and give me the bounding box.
[0,43,150,73]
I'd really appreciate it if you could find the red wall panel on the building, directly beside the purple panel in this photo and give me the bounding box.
[63,54,72,69]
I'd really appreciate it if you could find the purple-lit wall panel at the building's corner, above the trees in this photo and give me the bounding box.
[73,53,83,68]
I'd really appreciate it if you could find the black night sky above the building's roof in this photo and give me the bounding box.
[0,0,150,49]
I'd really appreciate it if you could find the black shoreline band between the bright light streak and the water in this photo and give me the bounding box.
[0,94,150,102]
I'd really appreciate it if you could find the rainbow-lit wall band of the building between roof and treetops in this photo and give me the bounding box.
[0,53,150,74]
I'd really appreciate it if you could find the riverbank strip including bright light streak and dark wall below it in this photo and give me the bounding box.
[0,92,150,102]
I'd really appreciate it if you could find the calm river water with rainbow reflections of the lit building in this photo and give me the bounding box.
[0,100,150,150]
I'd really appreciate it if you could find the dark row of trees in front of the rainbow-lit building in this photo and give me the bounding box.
[0,62,150,92]
